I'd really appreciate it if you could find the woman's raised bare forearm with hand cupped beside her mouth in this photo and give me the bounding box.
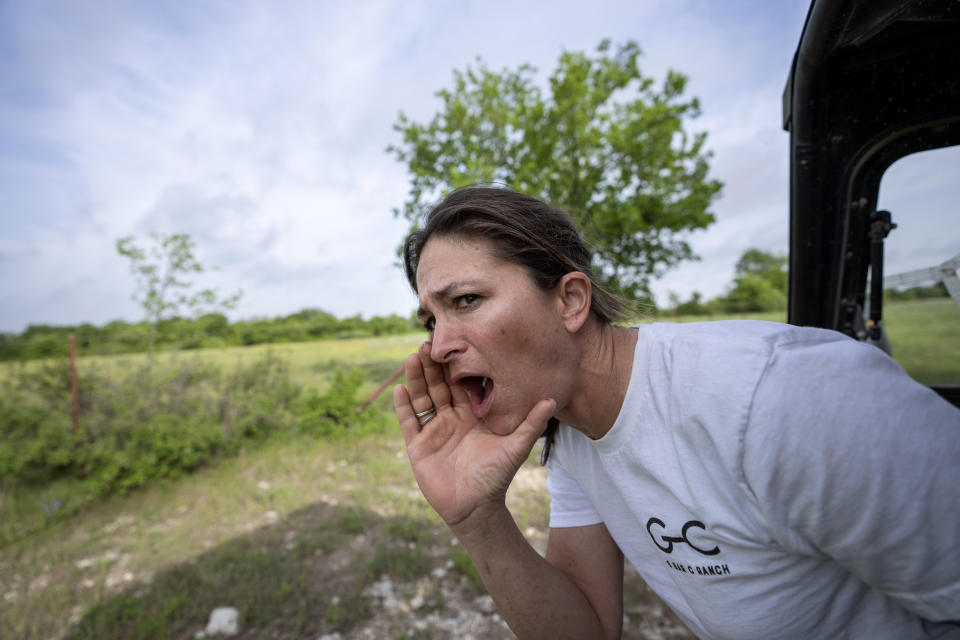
[394,344,623,639]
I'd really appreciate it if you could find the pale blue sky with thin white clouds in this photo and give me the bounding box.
[0,0,960,332]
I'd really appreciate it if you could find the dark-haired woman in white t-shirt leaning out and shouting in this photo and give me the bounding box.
[394,188,960,639]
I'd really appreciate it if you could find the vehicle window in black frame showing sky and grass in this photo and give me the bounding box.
[877,146,960,385]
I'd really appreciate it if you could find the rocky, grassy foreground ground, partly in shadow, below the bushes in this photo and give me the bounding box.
[0,443,693,640]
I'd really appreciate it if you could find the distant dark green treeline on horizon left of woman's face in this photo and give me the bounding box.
[0,309,420,361]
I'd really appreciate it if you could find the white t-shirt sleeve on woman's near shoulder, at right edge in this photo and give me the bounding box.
[742,340,960,621]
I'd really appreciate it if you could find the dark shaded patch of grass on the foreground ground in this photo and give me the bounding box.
[66,503,416,640]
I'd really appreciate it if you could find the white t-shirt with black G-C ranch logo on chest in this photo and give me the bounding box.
[547,321,960,640]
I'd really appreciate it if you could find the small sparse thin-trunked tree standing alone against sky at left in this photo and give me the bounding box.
[117,232,241,366]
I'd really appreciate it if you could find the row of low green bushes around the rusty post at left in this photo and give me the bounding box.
[0,354,383,495]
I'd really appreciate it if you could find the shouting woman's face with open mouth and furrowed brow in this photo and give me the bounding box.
[417,236,569,435]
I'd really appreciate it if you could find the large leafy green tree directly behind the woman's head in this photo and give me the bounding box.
[387,40,721,297]
